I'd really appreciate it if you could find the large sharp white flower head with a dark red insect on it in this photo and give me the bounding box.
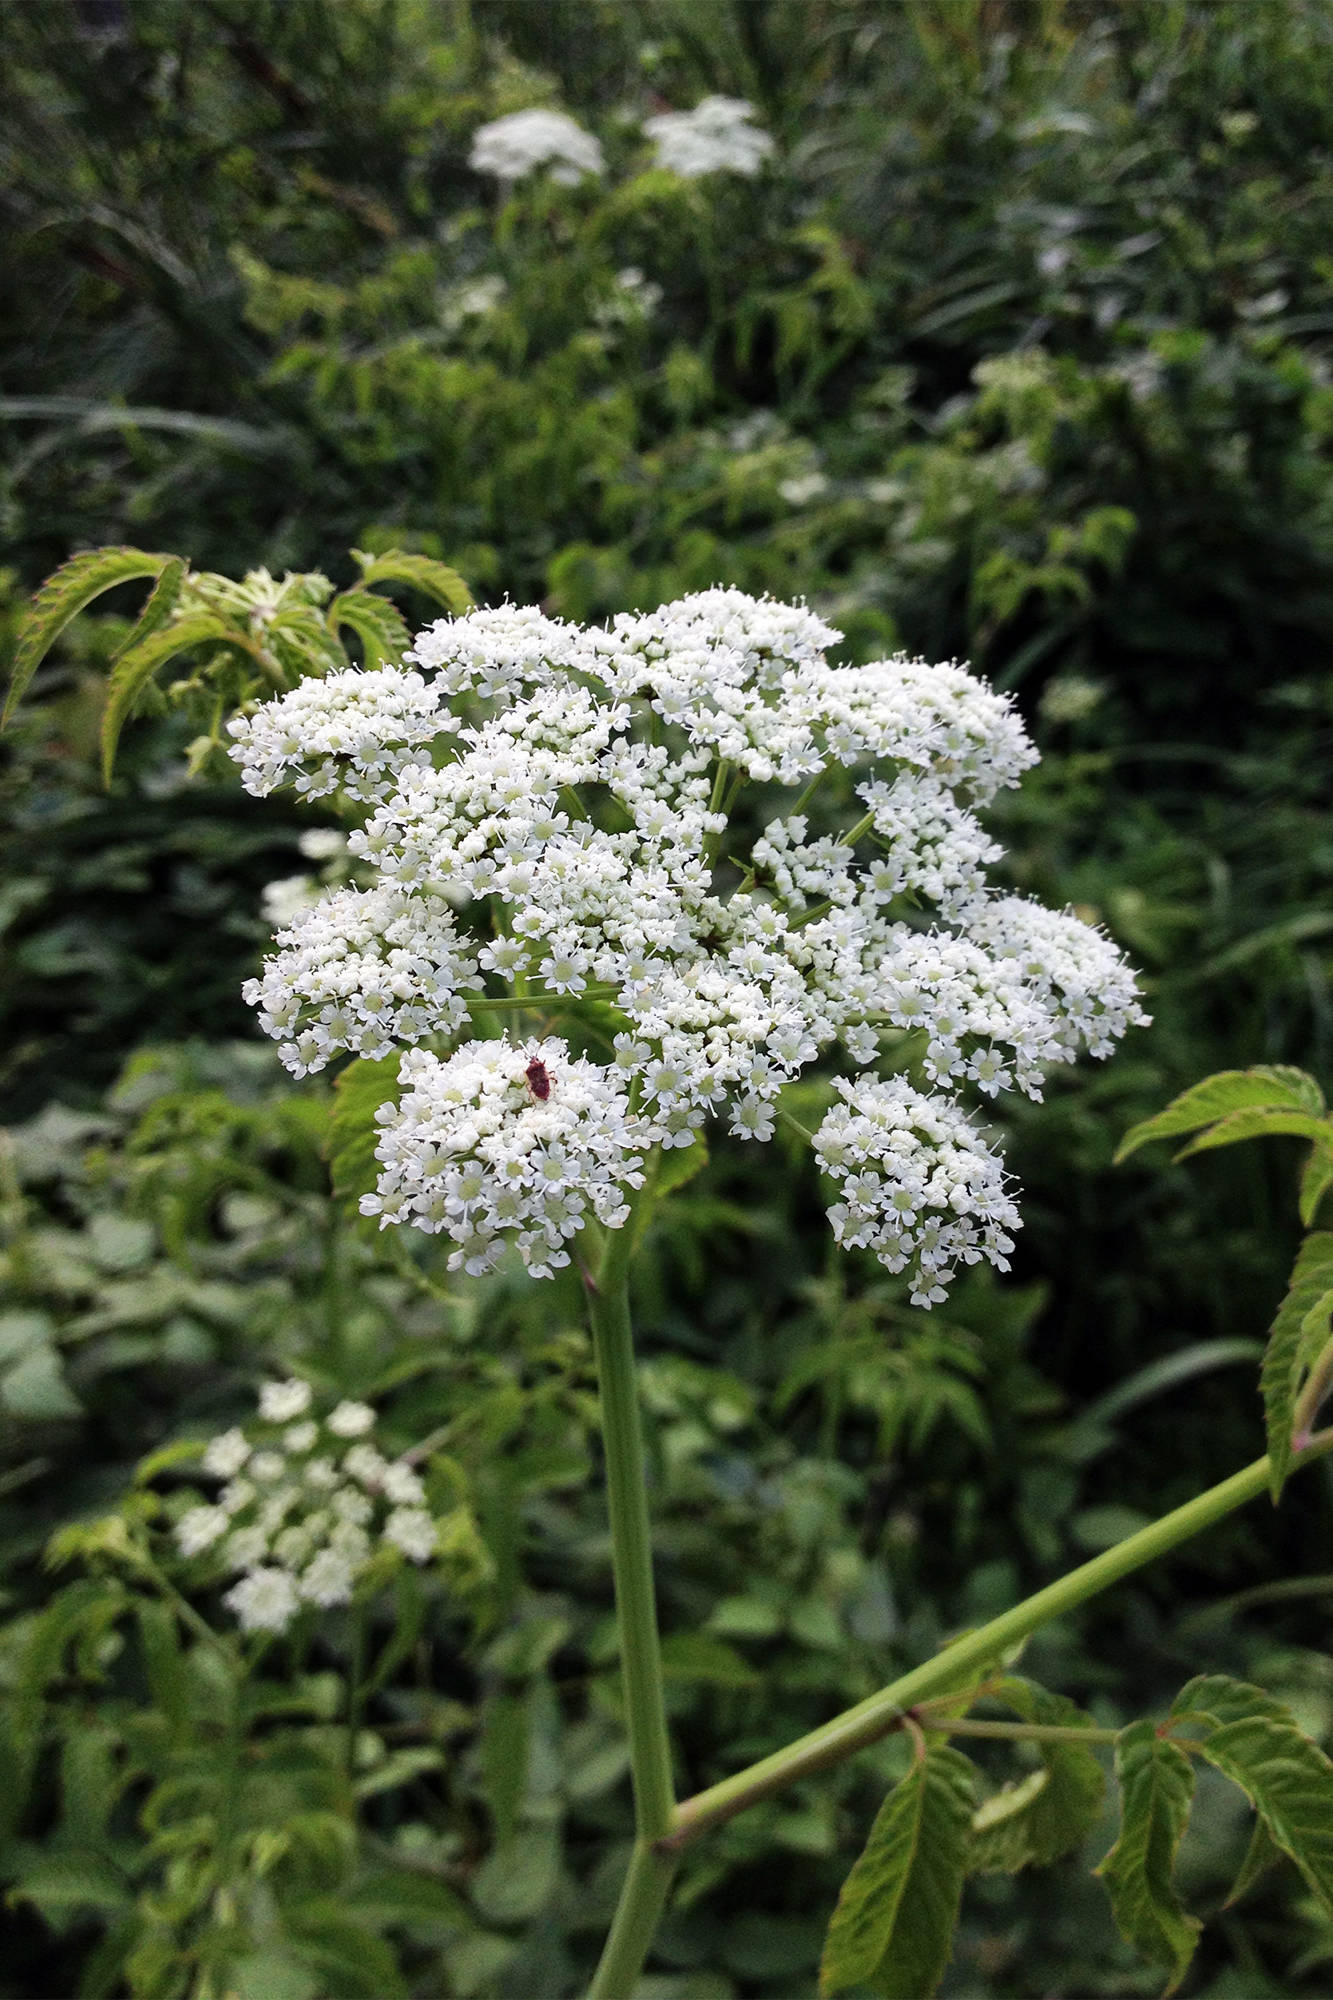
[230,590,1145,1304]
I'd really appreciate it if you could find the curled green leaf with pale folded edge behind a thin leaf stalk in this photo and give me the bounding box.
[967,1674,1107,1874]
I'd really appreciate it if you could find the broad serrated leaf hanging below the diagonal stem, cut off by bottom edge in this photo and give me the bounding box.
[819,1744,975,2000]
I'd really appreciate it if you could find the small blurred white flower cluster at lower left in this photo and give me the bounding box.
[176,1378,436,1632]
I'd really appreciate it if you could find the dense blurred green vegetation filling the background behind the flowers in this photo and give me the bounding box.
[0,0,1333,2000]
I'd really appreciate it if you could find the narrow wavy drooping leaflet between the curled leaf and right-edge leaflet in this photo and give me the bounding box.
[1097,1722,1199,1992]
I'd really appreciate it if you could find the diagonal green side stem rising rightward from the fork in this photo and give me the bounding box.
[662,1430,1333,1852]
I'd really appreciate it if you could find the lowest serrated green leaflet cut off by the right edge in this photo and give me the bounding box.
[1173,1674,1333,1910]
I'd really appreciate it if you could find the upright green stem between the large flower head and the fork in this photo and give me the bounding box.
[588,1228,675,1840]
